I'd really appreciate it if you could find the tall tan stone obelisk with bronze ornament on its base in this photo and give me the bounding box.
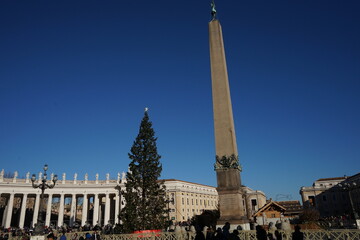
[209,2,249,229]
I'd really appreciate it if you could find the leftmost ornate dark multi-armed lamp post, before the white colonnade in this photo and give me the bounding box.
[31,164,57,235]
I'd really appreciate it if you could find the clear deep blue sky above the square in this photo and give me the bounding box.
[0,0,360,200]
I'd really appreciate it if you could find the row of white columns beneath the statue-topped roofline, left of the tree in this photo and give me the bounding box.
[0,189,121,228]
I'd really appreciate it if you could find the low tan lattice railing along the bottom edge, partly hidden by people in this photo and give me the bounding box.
[9,229,360,240]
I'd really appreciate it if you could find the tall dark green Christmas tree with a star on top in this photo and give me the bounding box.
[120,110,168,233]
